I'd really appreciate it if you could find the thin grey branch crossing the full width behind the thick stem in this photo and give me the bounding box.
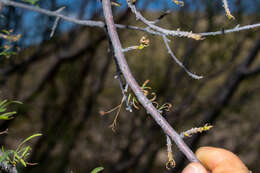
[0,0,260,37]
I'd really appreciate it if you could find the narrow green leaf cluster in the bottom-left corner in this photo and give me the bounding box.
[0,133,42,167]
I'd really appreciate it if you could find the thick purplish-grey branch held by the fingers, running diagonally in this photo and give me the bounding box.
[102,0,199,162]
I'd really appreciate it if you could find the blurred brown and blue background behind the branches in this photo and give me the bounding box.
[0,0,260,173]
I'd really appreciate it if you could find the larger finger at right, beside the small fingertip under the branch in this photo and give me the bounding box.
[196,147,249,173]
